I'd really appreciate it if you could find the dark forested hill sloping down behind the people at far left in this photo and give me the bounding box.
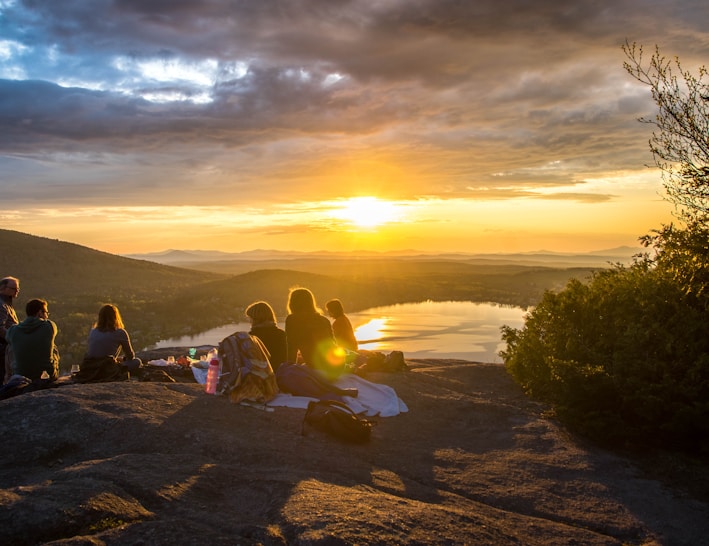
[0,229,225,368]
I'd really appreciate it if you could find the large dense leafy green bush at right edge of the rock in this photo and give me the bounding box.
[500,245,709,449]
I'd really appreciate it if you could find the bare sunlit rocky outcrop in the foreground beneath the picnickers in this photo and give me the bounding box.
[0,355,709,545]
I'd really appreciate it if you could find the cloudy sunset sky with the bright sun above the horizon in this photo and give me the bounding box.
[0,0,709,254]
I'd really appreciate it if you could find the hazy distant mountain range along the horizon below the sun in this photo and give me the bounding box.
[124,246,643,267]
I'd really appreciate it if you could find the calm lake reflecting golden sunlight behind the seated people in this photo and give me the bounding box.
[154,301,526,363]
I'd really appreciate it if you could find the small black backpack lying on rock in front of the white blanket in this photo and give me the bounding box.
[301,400,375,444]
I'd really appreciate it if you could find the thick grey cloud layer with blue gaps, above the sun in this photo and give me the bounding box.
[0,0,709,249]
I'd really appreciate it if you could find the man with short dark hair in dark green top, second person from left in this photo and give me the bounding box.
[6,299,59,382]
